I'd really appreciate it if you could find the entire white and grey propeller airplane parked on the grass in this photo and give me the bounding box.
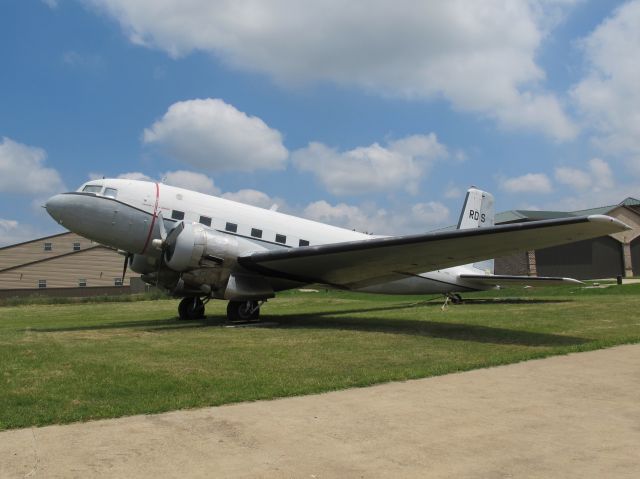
[45,178,629,322]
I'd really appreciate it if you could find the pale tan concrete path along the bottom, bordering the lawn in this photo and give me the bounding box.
[0,345,640,478]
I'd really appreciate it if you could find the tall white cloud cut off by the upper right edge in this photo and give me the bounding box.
[571,0,640,171]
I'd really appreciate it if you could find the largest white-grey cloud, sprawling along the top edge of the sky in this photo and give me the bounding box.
[87,0,577,140]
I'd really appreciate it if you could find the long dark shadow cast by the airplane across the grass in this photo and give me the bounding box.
[30,300,592,346]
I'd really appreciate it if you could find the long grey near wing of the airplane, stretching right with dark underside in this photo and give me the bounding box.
[238,215,629,289]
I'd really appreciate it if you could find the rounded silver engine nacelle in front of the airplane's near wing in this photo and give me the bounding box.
[164,223,239,272]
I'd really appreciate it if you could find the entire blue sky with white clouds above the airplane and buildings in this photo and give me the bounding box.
[0,0,640,246]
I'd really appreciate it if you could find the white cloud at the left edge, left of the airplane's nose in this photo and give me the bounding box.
[0,137,66,195]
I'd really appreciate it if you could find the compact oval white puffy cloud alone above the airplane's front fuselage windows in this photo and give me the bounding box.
[143,98,288,171]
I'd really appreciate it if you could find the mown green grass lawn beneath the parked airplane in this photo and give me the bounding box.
[0,284,640,429]
